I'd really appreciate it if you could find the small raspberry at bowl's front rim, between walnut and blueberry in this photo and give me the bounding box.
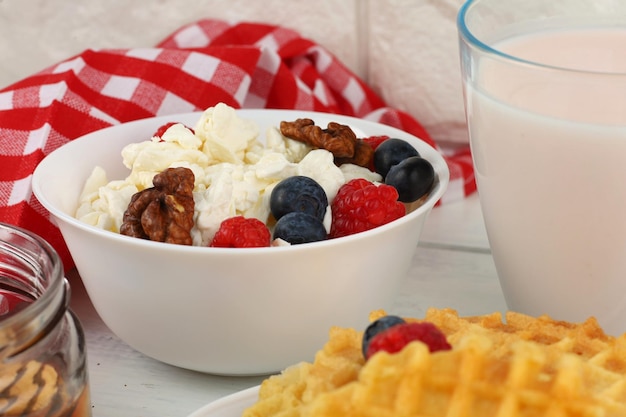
[209,216,271,248]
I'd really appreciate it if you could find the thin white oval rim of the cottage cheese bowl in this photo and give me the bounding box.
[32,109,450,256]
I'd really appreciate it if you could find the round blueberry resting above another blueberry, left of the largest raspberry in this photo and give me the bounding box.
[270,175,328,221]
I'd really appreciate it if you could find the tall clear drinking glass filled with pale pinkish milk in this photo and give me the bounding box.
[457,0,626,334]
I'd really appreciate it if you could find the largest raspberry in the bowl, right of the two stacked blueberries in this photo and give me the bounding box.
[329,178,406,238]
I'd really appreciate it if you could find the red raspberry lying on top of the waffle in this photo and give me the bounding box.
[365,322,452,359]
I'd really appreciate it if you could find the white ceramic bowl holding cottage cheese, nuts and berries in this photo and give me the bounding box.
[33,110,449,375]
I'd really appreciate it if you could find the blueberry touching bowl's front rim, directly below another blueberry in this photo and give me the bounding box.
[273,211,326,245]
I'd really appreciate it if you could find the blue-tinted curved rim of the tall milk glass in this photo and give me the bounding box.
[456,0,626,77]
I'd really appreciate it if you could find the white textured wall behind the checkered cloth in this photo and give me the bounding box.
[0,0,467,143]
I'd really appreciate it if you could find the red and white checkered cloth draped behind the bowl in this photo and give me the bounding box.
[0,20,475,269]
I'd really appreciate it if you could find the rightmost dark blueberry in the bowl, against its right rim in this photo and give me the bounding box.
[385,156,435,203]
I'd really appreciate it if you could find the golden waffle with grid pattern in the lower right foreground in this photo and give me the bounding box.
[243,309,626,417]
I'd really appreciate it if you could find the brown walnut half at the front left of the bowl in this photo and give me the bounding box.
[120,168,195,245]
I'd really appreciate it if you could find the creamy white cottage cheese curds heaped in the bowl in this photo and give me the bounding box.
[76,103,382,246]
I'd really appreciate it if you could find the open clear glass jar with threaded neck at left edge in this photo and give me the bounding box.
[0,223,91,417]
